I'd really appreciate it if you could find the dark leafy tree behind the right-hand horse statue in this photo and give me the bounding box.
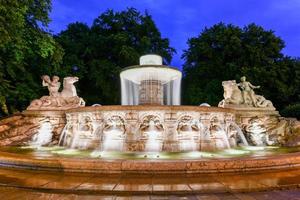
[182,23,300,109]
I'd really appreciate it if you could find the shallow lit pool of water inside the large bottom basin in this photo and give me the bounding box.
[0,146,300,160]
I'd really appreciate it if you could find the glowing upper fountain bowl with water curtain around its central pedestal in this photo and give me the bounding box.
[120,55,182,105]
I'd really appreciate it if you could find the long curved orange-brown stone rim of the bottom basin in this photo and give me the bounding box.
[0,152,300,174]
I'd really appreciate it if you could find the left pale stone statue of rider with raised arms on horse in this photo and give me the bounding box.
[27,75,85,110]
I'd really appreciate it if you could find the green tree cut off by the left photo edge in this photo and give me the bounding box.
[0,0,63,115]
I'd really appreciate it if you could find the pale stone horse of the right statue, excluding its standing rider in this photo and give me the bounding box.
[219,80,274,108]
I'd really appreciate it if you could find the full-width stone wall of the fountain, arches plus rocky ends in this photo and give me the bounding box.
[0,106,300,148]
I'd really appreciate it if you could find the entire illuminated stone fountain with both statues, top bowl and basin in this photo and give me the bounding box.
[0,55,300,172]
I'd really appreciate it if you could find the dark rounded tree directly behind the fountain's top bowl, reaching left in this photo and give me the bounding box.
[56,8,175,105]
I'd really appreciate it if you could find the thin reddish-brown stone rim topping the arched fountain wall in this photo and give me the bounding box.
[66,105,235,114]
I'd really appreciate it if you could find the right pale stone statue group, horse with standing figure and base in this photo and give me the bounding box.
[219,76,275,110]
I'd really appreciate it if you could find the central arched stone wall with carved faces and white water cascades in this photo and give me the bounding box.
[61,106,241,152]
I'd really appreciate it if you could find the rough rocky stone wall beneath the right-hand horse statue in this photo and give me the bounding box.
[230,106,300,146]
